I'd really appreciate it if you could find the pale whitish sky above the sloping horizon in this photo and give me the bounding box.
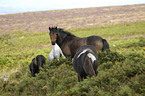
[0,0,145,12]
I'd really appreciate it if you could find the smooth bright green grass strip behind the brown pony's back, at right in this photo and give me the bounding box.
[70,21,145,38]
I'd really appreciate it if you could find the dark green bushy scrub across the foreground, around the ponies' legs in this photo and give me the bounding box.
[0,52,145,96]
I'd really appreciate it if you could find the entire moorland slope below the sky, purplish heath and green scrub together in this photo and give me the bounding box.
[0,5,145,96]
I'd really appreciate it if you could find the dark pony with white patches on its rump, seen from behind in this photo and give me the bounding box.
[73,45,98,82]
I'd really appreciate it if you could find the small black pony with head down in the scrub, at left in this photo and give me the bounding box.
[29,55,45,77]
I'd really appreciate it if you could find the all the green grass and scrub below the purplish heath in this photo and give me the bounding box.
[0,21,145,96]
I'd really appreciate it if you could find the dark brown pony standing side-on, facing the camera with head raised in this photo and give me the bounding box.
[49,27,109,60]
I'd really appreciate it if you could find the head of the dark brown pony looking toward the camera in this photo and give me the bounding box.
[49,27,58,45]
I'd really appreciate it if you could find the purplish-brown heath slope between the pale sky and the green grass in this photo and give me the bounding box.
[0,5,145,33]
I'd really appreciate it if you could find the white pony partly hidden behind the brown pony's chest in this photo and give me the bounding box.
[48,43,64,61]
